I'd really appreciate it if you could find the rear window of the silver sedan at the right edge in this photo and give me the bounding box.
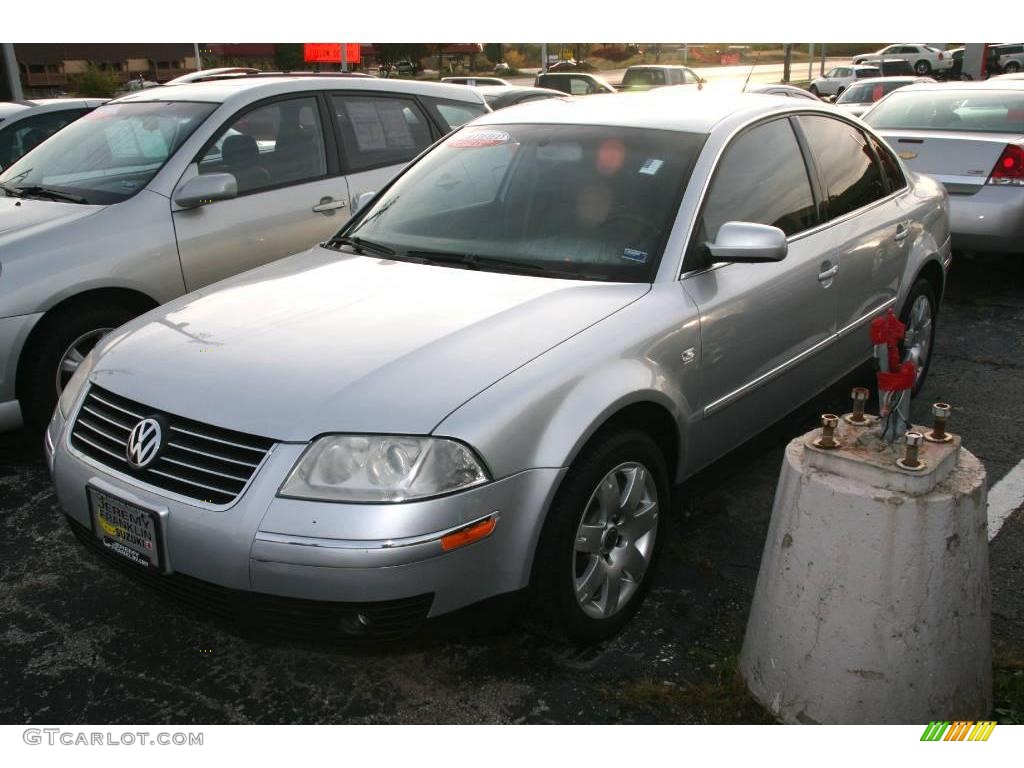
[865,89,1024,133]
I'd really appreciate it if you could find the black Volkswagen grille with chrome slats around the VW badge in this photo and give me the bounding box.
[71,385,273,506]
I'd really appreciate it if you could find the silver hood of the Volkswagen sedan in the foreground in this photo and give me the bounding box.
[90,248,650,441]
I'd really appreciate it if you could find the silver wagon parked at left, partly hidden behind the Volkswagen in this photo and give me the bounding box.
[0,75,489,431]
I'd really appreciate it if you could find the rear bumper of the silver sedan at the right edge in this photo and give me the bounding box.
[949,184,1024,253]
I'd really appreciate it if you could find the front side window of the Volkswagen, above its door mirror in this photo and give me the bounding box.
[698,119,816,249]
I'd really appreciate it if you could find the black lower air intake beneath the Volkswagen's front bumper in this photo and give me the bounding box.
[67,517,434,640]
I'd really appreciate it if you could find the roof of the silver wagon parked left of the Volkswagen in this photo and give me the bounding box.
[114,75,482,103]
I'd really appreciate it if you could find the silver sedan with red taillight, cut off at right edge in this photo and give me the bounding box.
[863,79,1024,253]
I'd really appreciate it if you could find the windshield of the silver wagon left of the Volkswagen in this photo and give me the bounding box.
[0,101,217,205]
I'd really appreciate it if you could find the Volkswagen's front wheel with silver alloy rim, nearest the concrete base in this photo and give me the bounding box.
[531,429,669,643]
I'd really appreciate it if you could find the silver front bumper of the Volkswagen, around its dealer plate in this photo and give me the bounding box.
[44,411,564,616]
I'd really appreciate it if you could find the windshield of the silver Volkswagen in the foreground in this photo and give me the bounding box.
[344,125,706,283]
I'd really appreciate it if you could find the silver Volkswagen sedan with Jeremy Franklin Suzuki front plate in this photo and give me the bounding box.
[46,89,949,640]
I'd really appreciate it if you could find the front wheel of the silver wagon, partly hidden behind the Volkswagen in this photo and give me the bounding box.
[18,304,137,434]
